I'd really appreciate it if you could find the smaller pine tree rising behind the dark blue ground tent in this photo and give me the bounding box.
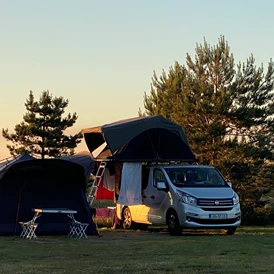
[2,91,82,159]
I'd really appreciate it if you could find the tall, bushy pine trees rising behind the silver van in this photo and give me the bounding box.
[139,36,274,225]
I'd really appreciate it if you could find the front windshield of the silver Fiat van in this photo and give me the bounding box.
[165,166,229,187]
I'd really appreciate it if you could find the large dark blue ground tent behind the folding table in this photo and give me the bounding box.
[0,153,97,235]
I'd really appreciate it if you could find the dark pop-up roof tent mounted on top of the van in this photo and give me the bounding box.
[82,115,196,162]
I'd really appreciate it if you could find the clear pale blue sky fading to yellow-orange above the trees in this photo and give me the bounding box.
[0,0,274,160]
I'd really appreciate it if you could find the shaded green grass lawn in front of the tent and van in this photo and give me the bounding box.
[0,227,274,274]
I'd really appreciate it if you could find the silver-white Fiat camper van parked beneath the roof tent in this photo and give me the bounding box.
[117,164,241,235]
